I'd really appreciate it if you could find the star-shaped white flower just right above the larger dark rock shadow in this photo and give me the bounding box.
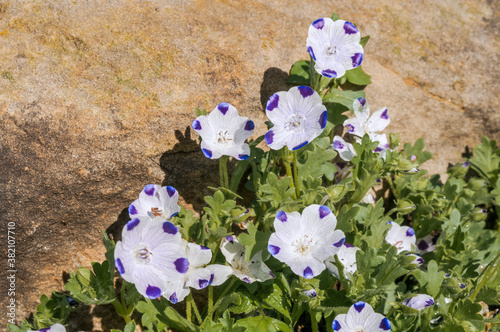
[192,103,255,160]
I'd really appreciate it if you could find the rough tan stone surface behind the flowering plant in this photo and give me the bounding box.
[0,0,500,330]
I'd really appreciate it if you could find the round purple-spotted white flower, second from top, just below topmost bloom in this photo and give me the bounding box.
[265,86,326,150]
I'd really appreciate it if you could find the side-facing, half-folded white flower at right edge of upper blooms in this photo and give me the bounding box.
[344,98,391,153]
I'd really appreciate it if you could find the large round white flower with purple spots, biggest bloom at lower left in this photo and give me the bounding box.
[115,217,189,299]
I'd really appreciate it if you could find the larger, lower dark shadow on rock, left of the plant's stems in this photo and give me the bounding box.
[160,126,219,212]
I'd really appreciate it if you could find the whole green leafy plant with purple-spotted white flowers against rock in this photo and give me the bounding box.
[9,11,500,332]
